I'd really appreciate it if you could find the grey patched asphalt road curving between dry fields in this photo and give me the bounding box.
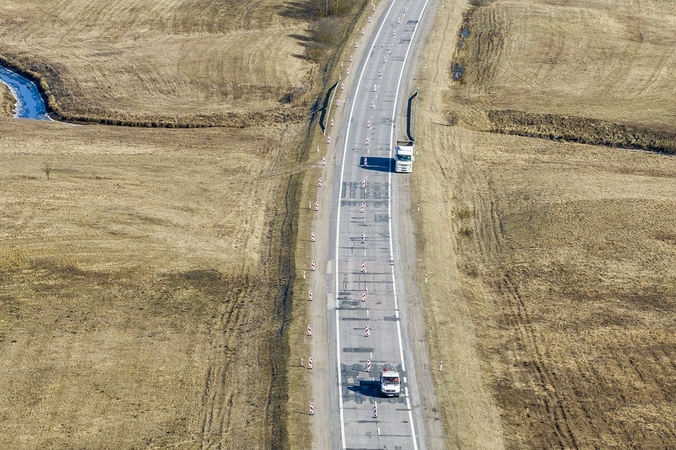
[326,0,440,450]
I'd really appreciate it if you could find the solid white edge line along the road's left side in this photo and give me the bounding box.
[335,1,394,450]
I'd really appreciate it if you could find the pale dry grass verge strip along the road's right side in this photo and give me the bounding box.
[411,2,504,449]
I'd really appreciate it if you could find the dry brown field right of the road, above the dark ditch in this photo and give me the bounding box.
[449,0,676,152]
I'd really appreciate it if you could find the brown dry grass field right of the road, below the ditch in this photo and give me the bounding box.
[461,135,676,448]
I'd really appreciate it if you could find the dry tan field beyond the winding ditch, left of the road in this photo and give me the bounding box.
[0,0,315,126]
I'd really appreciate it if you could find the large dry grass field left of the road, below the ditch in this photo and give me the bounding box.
[0,119,304,449]
